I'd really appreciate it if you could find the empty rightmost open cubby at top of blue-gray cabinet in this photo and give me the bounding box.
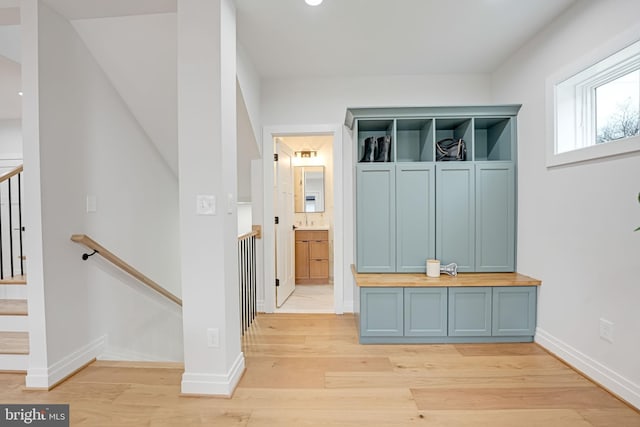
[474,117,513,161]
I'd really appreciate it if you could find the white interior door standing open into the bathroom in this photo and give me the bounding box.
[274,139,295,307]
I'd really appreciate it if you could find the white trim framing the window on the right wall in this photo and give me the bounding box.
[545,25,640,167]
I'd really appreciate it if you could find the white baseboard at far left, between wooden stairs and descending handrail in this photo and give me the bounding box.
[26,336,106,388]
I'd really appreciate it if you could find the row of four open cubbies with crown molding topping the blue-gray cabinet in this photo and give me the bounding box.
[345,105,521,162]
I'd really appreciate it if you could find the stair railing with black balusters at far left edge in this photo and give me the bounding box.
[0,165,25,280]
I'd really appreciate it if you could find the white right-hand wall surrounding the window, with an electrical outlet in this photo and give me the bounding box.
[492,0,640,407]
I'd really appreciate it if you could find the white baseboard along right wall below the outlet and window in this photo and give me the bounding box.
[535,328,640,409]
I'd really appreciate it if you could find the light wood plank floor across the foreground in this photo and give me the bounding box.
[0,314,640,427]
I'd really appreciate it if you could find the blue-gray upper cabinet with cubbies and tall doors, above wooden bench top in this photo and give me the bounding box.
[346,105,520,273]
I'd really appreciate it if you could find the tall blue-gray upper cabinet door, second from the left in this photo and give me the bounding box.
[396,163,436,273]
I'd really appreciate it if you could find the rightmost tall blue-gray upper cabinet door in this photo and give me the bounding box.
[475,162,516,272]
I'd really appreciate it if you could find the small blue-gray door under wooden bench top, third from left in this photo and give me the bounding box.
[449,287,492,337]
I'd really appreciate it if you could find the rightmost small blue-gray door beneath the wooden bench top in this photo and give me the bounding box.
[492,286,537,336]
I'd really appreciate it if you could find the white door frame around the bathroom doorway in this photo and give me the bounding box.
[262,124,344,314]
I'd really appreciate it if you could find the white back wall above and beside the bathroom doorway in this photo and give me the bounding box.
[254,74,491,311]
